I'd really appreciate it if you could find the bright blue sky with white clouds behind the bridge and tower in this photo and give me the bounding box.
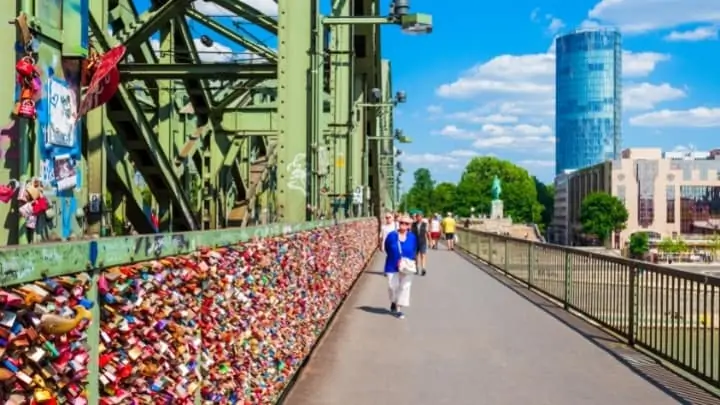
[129,0,720,187]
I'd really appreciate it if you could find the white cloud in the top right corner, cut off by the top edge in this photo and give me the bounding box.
[588,0,720,33]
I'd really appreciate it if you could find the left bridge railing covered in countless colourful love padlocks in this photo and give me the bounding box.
[0,219,378,405]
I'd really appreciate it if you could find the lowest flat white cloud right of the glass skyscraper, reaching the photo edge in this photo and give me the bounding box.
[630,107,720,128]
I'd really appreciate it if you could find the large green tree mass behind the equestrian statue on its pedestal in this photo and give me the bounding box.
[454,157,542,223]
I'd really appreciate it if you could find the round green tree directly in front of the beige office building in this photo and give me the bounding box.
[580,192,628,242]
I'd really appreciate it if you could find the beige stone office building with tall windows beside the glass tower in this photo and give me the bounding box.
[553,148,720,248]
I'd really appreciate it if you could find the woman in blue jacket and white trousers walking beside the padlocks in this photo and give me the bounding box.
[384,215,418,319]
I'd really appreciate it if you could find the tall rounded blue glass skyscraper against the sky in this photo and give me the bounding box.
[555,29,622,174]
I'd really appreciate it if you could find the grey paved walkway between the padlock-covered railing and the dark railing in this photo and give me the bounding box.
[285,250,720,405]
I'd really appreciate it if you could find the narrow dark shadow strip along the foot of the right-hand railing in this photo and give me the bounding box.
[457,250,720,405]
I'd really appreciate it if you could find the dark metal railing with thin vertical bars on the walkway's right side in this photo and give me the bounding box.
[457,229,720,386]
